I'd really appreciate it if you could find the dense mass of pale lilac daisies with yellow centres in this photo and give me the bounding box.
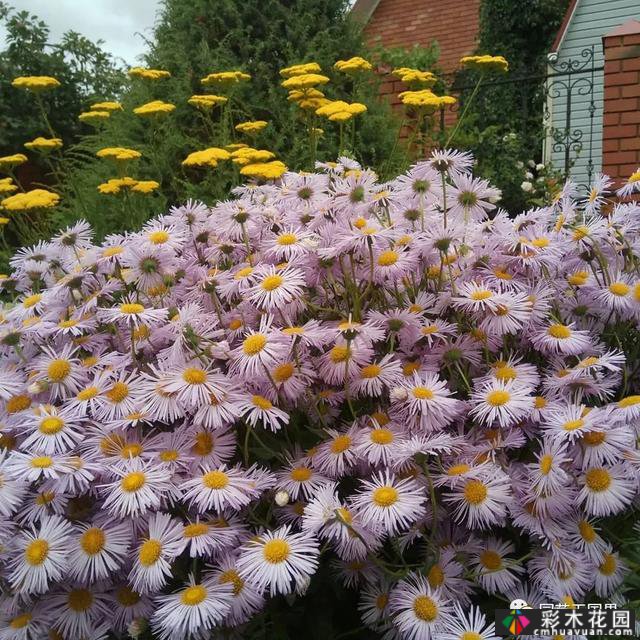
[0,151,640,640]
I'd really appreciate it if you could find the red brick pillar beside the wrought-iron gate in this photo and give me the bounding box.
[602,20,640,181]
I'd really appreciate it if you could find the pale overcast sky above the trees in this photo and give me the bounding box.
[0,0,158,64]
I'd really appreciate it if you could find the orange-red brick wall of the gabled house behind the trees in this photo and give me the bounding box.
[365,0,480,72]
